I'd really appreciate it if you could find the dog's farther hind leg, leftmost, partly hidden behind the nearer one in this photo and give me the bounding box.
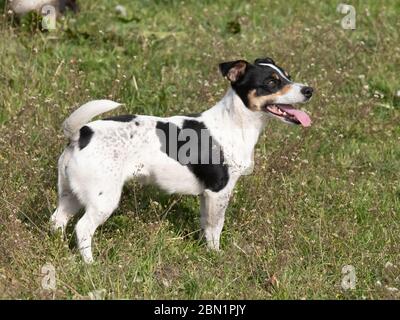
[50,149,82,233]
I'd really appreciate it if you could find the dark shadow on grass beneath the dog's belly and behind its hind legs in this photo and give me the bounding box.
[20,177,200,249]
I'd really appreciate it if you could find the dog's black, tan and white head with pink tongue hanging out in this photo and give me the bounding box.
[219,58,313,127]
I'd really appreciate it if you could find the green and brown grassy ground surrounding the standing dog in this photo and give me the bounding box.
[0,0,400,299]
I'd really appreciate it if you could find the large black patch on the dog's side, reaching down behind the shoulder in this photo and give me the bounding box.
[156,120,229,192]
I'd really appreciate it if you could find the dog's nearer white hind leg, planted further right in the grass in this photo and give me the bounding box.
[75,181,123,263]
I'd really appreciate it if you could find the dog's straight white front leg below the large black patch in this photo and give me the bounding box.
[200,190,231,251]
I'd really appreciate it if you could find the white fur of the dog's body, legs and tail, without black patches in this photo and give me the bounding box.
[51,89,306,263]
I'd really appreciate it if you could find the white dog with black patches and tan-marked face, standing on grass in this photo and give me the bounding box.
[51,58,313,263]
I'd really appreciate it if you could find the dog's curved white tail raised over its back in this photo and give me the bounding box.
[62,100,121,140]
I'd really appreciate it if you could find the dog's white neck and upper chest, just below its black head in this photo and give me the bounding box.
[203,88,267,171]
